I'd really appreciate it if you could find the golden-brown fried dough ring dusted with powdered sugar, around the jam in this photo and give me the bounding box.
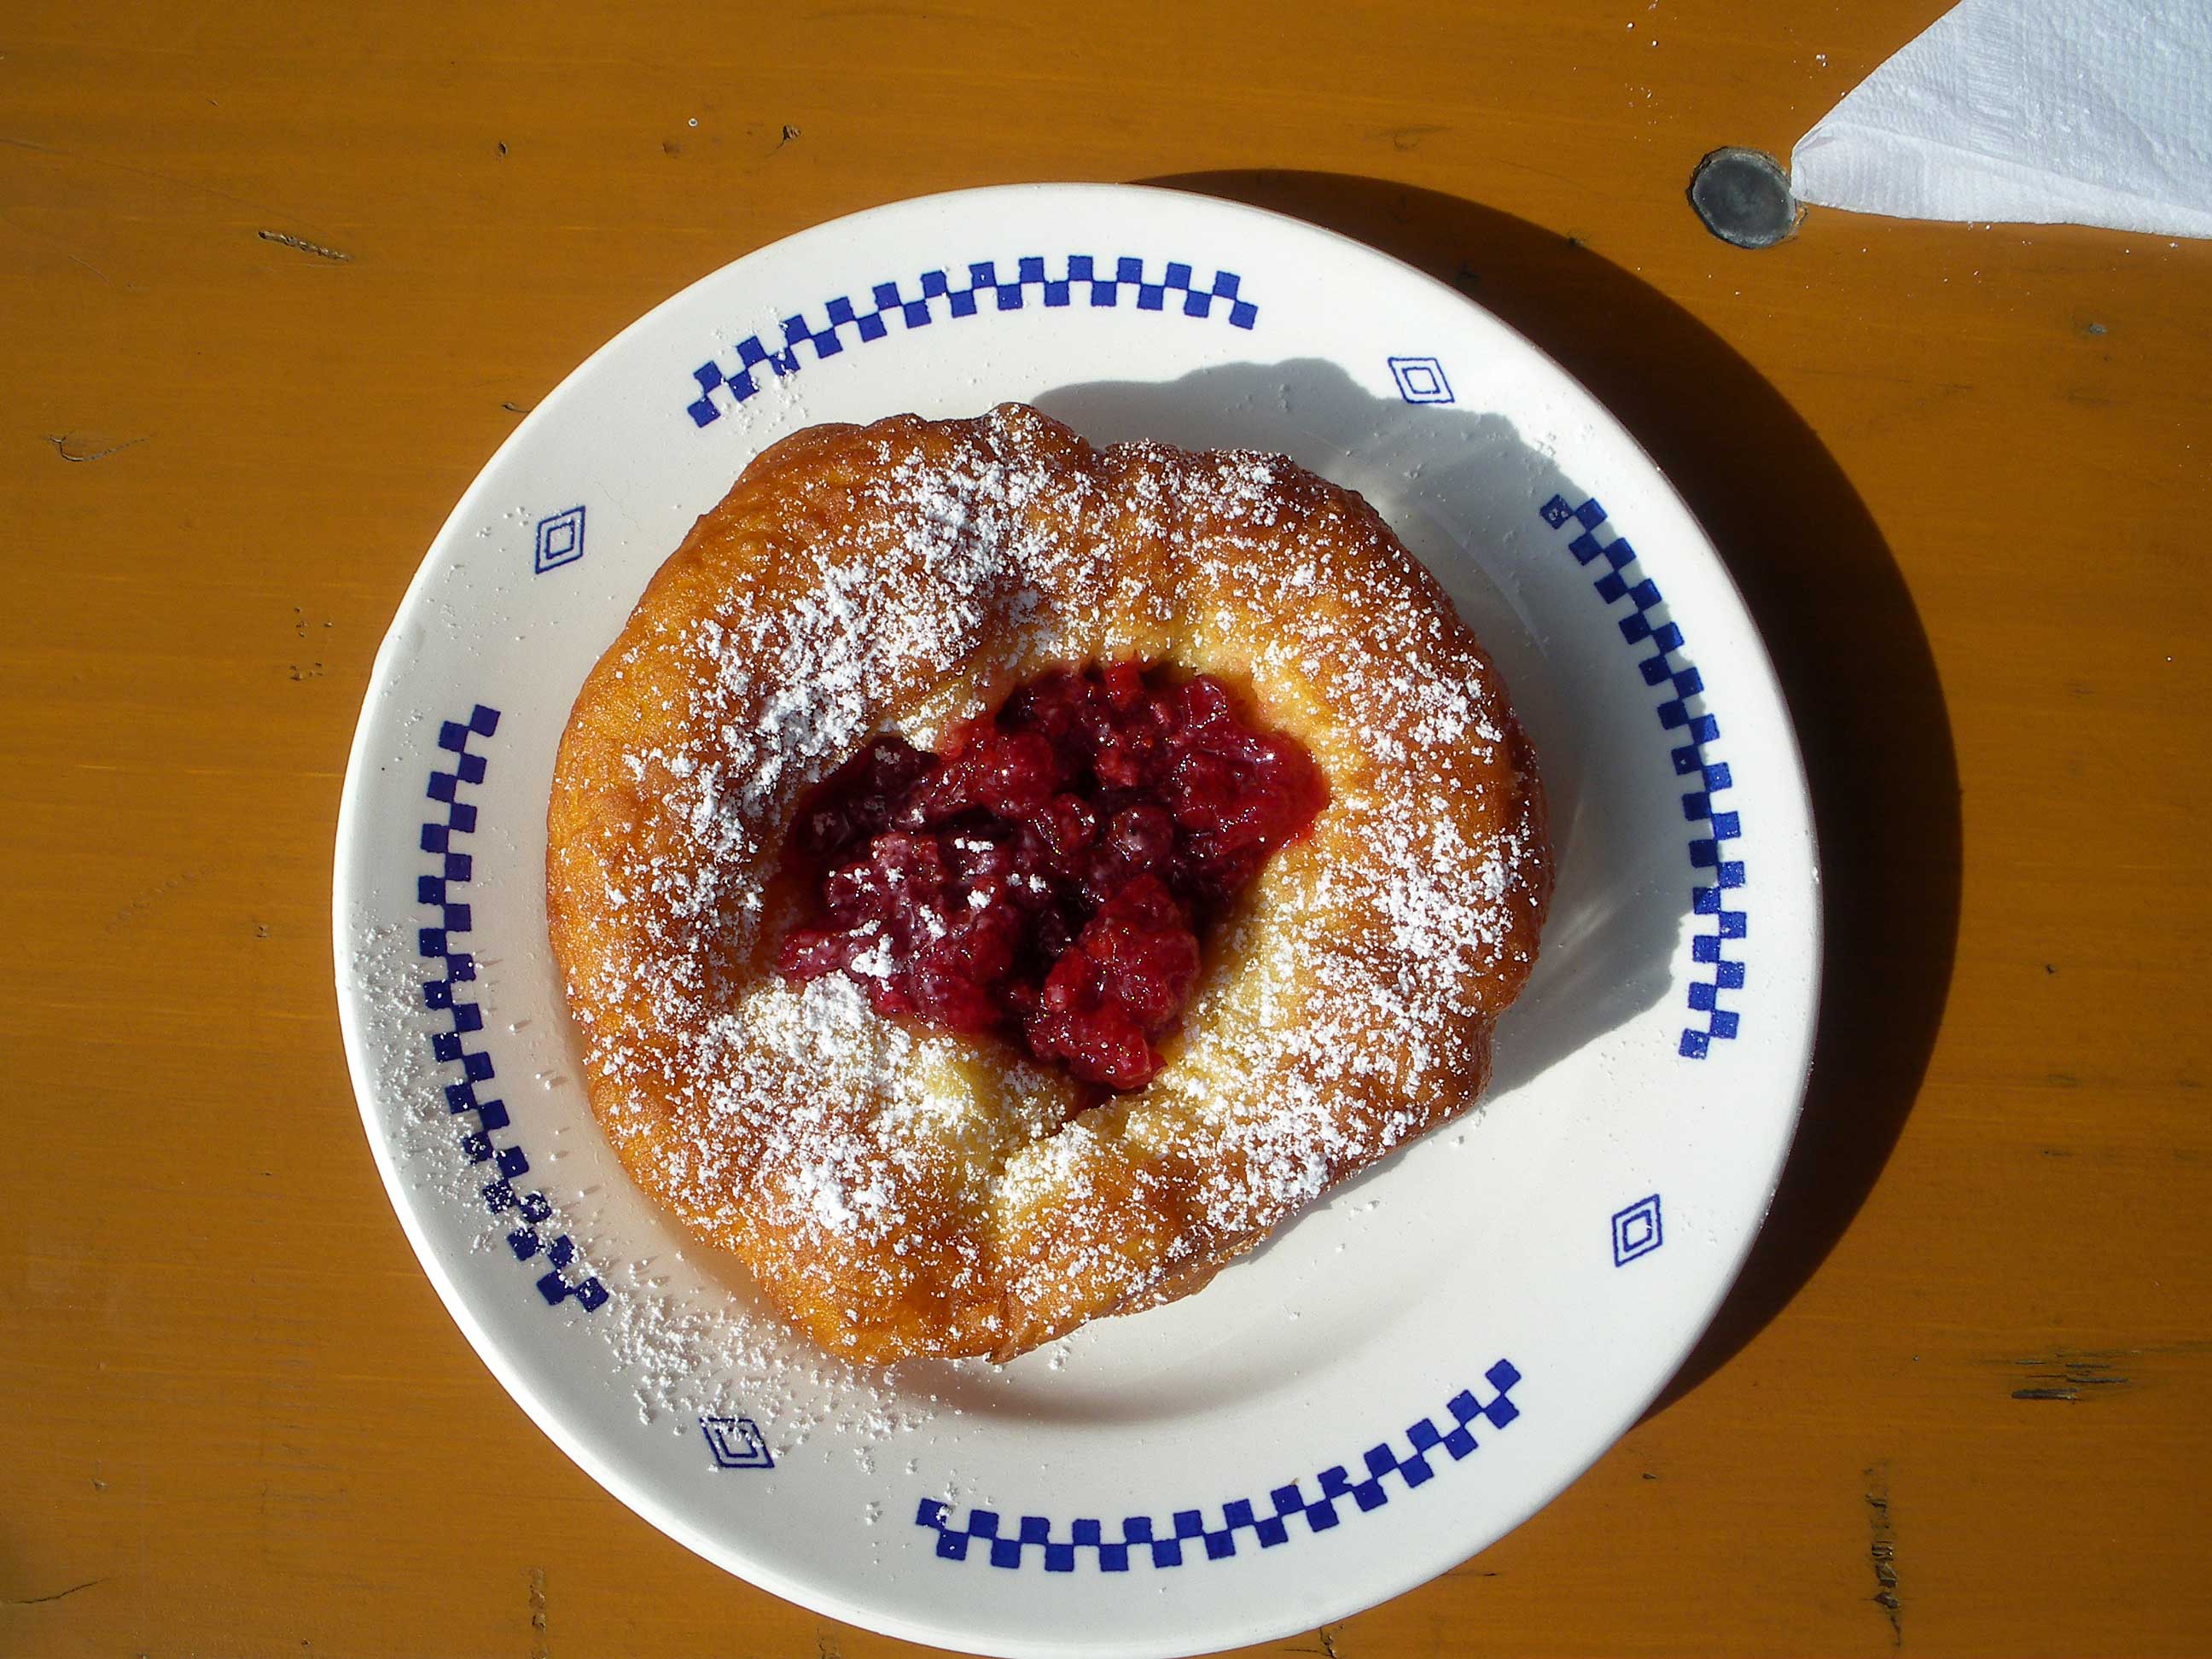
[546,405,1551,1363]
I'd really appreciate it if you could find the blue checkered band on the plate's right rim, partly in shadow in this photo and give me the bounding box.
[1540,496,1749,1060]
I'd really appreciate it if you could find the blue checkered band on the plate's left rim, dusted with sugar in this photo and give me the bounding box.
[416,703,606,1314]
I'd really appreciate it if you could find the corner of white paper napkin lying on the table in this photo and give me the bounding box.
[1790,0,2212,236]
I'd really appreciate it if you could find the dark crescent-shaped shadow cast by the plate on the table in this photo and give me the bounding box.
[1137,171,1960,1413]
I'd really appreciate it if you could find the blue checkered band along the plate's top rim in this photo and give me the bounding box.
[686,254,1259,427]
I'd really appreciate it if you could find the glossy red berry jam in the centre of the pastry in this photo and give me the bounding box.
[777,661,1330,1088]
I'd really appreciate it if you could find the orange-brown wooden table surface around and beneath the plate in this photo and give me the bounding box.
[0,0,2212,1659]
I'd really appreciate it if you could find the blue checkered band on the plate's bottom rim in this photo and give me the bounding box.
[913,1360,1522,1573]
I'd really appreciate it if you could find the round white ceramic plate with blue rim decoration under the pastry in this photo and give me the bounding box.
[336,186,1820,1655]
